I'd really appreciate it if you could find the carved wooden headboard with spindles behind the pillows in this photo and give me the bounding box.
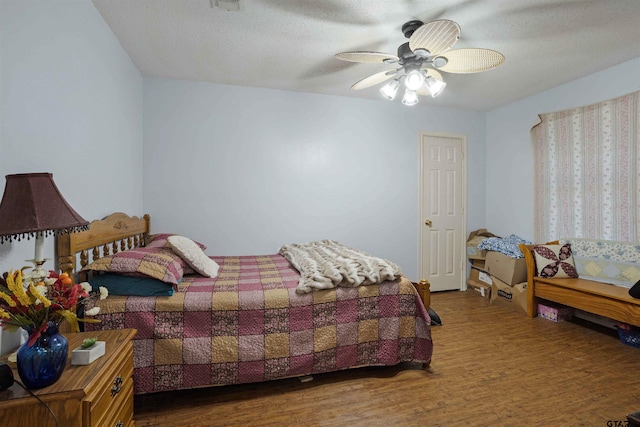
[56,212,151,280]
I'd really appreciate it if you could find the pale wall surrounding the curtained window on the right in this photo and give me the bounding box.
[486,58,640,240]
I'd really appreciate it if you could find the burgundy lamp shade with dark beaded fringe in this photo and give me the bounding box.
[0,173,89,243]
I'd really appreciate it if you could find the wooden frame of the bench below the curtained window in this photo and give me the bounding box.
[520,242,640,326]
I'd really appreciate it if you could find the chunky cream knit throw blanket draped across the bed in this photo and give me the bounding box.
[279,240,402,294]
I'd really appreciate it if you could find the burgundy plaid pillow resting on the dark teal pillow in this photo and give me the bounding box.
[83,247,184,288]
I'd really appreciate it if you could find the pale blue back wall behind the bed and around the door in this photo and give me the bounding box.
[143,78,485,279]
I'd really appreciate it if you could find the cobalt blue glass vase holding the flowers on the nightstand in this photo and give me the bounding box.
[16,322,69,389]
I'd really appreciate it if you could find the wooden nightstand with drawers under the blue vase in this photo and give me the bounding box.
[0,329,136,427]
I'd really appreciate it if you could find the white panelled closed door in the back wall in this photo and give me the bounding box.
[419,132,467,291]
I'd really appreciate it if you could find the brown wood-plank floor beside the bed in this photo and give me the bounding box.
[135,291,640,427]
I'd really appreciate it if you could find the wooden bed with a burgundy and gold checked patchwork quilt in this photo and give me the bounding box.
[56,213,433,394]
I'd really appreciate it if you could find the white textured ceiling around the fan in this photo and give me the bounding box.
[93,0,640,111]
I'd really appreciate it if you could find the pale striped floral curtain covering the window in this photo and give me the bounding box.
[531,92,640,242]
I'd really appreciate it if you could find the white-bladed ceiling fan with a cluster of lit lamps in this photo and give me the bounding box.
[336,19,504,105]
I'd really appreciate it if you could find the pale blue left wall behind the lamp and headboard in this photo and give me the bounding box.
[0,0,142,354]
